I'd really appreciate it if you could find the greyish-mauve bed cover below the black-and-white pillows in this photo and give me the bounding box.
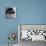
[20,40,46,46]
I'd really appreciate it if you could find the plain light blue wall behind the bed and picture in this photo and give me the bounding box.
[0,0,46,43]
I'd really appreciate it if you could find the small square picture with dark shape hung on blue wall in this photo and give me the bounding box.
[5,7,16,19]
